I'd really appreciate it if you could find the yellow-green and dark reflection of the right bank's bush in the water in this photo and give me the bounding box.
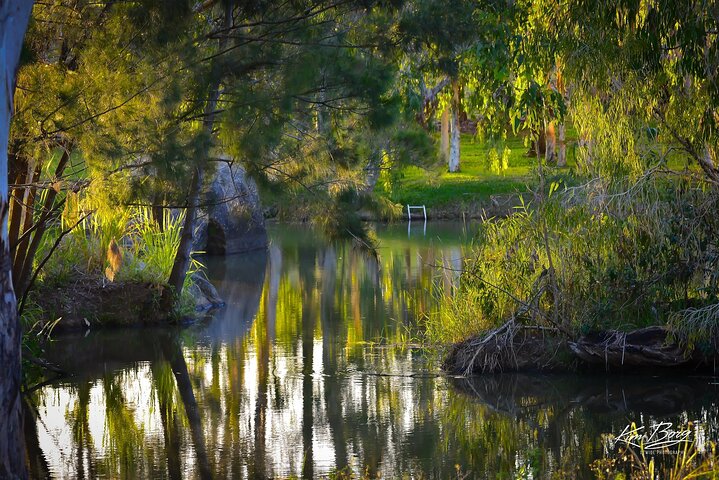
[442,374,719,478]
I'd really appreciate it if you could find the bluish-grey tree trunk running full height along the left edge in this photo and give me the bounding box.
[0,0,32,478]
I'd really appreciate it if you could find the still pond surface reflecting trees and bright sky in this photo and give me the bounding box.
[25,223,719,479]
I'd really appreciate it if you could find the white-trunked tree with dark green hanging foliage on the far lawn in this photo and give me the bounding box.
[400,0,527,172]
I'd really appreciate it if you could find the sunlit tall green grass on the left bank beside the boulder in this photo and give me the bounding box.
[22,203,202,333]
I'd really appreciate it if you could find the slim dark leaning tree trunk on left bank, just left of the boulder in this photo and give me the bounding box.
[168,0,234,298]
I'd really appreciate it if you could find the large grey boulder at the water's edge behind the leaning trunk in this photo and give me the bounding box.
[195,161,267,255]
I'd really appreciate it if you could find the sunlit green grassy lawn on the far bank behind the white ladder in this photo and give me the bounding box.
[377,135,574,207]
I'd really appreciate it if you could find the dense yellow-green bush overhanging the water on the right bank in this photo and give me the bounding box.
[428,174,719,341]
